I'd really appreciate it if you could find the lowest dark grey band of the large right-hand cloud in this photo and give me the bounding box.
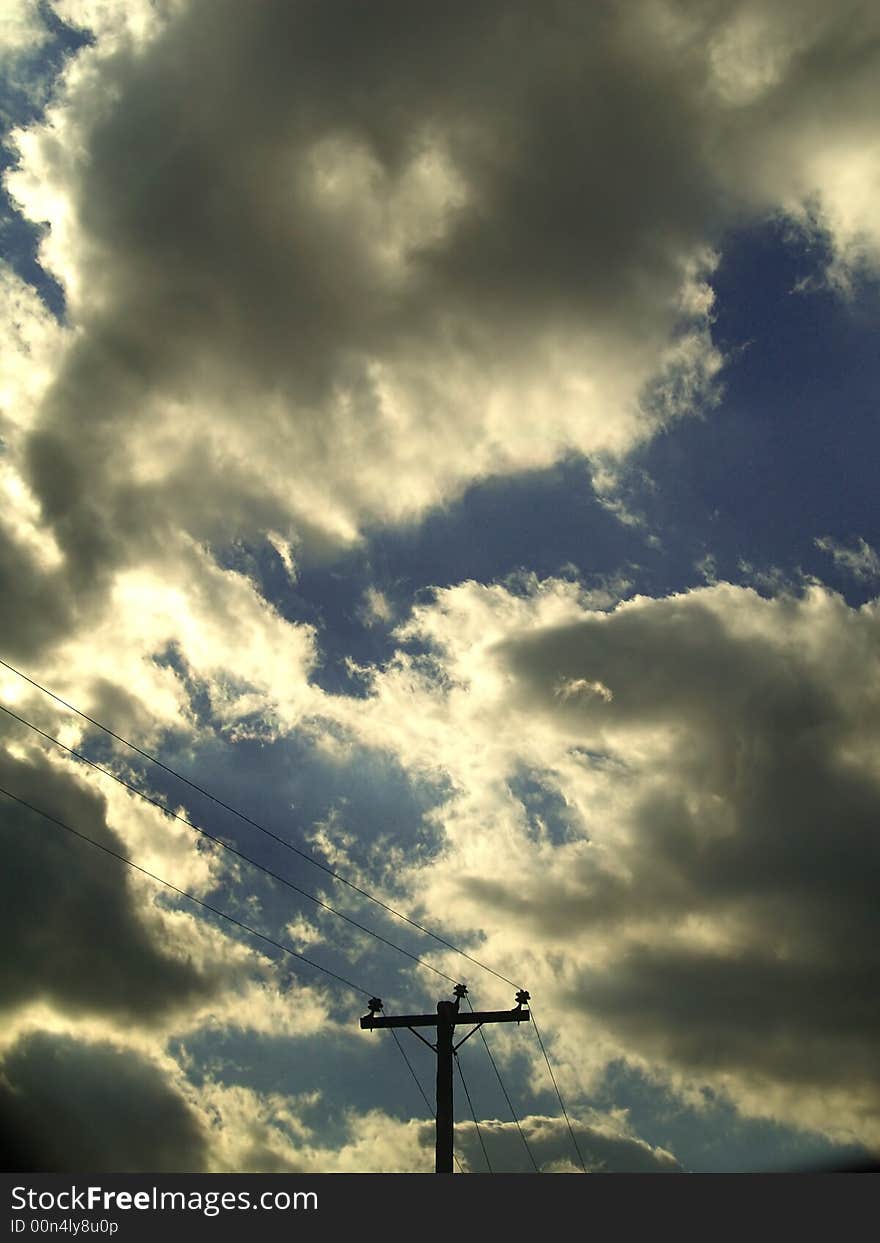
[568,939,880,1088]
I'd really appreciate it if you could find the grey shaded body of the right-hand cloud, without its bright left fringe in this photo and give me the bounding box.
[482,587,880,1110]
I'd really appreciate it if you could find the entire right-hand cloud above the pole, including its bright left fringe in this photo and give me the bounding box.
[325,580,880,1144]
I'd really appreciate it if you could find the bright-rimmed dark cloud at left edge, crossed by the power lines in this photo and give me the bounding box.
[0,717,343,1055]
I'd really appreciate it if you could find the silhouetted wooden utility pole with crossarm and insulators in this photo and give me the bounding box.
[360,984,531,1173]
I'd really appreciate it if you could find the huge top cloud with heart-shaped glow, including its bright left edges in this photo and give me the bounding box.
[0,0,878,723]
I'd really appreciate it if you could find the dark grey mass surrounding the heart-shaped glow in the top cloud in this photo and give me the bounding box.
[8,0,735,594]
